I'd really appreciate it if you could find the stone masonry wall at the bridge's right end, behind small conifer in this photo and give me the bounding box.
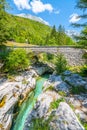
[58,48,85,66]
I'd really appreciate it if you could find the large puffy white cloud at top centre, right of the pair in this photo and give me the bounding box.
[30,0,53,13]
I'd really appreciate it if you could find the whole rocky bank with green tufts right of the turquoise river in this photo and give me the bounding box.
[24,71,87,130]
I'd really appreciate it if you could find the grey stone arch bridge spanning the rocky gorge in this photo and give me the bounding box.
[9,46,86,66]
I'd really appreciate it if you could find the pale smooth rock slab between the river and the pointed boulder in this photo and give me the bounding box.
[24,91,61,130]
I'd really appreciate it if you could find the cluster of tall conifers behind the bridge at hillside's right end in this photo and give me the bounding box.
[45,25,75,45]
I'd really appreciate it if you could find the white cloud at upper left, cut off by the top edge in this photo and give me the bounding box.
[14,0,31,10]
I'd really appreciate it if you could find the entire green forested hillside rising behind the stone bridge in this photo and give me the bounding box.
[0,11,74,45]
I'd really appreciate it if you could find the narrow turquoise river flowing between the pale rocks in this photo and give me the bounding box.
[12,76,48,130]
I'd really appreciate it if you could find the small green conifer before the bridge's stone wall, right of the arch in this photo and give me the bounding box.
[55,54,67,74]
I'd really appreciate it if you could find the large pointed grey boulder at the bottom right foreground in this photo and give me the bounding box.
[50,102,85,130]
